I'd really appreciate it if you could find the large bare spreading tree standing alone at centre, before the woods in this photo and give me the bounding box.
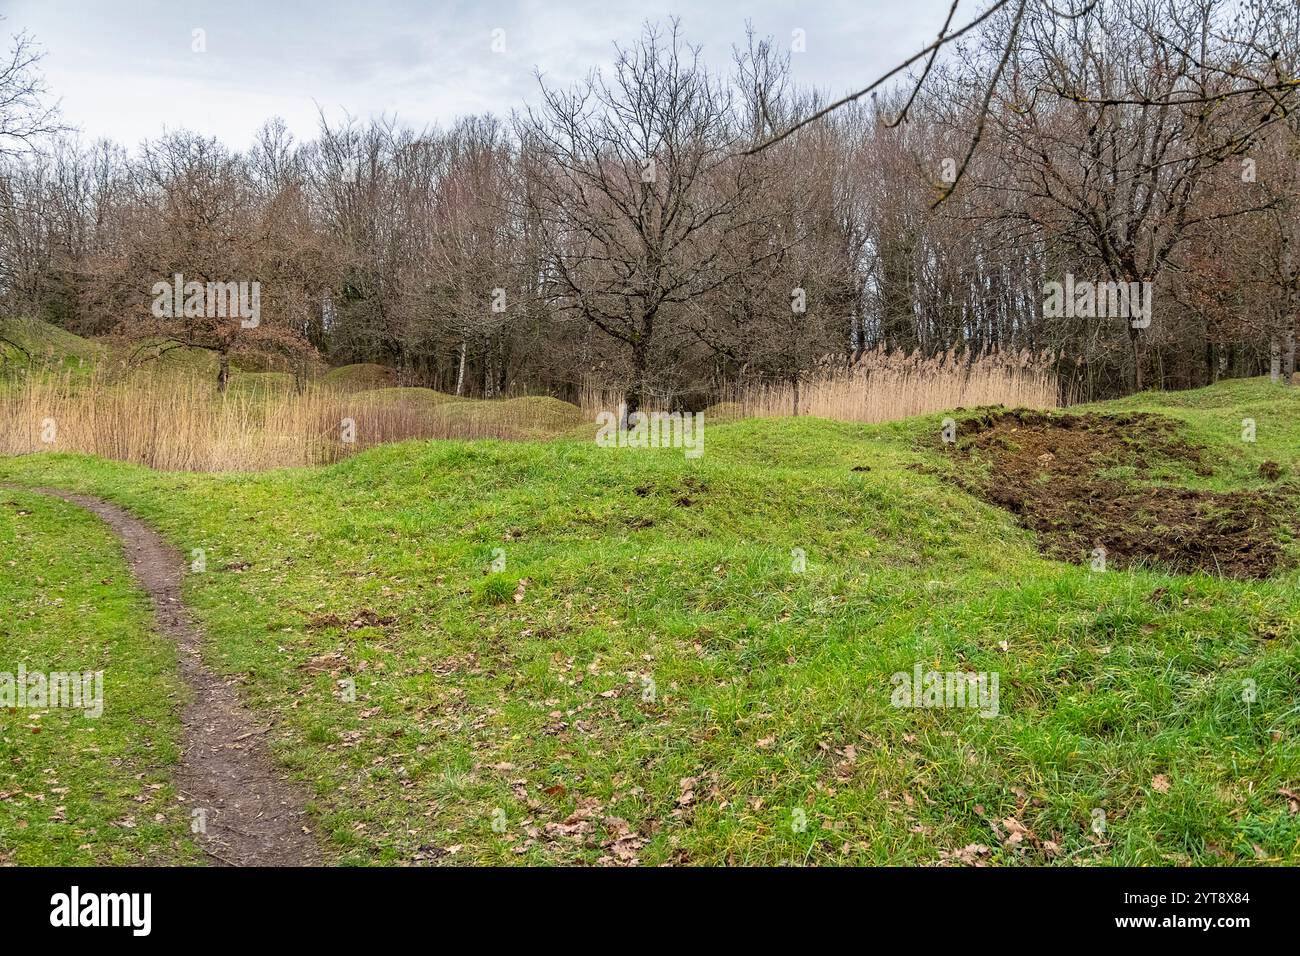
[520,21,779,414]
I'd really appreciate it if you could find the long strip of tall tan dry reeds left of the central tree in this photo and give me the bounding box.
[0,372,569,471]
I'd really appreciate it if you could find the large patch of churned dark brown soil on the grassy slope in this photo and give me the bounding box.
[954,410,1295,579]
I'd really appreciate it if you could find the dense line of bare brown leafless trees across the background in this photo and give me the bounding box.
[0,0,1300,411]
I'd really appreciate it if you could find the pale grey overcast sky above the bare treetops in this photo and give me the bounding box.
[0,0,956,148]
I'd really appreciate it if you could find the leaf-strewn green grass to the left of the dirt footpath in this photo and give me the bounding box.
[0,489,198,866]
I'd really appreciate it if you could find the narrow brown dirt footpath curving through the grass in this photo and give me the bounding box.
[29,488,321,866]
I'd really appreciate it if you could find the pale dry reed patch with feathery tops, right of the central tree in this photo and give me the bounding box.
[729,351,1061,421]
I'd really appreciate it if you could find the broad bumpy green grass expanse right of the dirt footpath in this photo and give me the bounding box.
[0,381,1300,865]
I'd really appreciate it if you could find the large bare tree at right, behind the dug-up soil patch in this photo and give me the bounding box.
[974,0,1297,390]
